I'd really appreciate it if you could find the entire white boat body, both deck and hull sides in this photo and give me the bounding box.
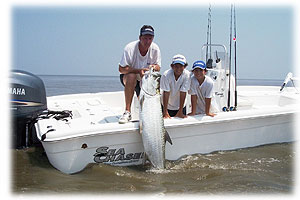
[35,87,299,174]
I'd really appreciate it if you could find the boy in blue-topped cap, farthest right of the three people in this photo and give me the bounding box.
[188,60,216,117]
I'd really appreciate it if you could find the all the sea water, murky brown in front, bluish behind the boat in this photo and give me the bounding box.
[11,76,296,195]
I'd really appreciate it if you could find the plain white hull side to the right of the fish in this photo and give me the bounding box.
[166,111,294,160]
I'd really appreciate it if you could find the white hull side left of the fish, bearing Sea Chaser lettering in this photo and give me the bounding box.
[42,131,144,174]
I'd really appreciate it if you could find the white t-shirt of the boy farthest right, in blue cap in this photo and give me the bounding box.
[189,76,214,114]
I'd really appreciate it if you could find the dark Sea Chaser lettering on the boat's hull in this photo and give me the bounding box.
[94,147,144,164]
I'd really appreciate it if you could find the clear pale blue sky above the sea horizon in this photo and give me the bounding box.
[11,3,296,79]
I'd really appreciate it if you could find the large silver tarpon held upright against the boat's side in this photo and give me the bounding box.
[139,68,172,169]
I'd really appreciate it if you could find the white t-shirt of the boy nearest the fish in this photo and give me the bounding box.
[160,69,190,110]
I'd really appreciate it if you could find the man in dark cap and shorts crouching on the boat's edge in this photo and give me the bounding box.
[119,25,161,124]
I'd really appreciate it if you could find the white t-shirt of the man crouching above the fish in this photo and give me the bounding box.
[119,40,161,69]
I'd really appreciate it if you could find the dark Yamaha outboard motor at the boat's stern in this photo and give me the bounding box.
[8,70,47,148]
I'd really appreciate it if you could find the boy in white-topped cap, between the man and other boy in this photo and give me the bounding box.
[160,54,190,118]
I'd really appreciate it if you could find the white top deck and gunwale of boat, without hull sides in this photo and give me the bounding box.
[38,86,299,141]
